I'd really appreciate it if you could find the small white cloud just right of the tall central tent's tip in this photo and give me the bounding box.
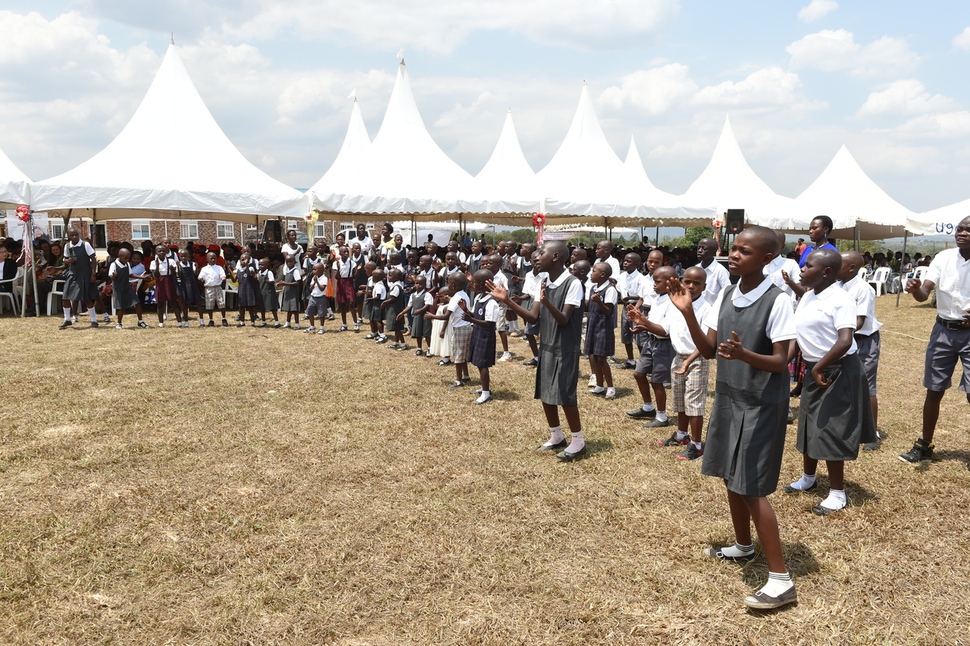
[600,63,697,115]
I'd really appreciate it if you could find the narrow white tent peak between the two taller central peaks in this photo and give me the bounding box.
[462,110,540,225]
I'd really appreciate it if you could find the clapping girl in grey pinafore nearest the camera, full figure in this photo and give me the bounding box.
[669,226,798,610]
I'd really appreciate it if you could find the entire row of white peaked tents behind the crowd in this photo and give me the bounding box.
[0,45,970,239]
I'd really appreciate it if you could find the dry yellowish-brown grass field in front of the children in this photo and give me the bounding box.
[0,296,970,646]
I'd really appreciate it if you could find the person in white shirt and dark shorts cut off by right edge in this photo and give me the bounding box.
[899,216,970,464]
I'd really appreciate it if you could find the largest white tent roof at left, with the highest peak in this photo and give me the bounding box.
[31,45,307,218]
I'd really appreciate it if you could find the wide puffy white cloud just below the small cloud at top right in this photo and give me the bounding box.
[785,29,920,76]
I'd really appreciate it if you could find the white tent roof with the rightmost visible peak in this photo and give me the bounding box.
[795,146,915,240]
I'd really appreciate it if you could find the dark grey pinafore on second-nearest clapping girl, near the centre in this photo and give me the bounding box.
[535,270,583,406]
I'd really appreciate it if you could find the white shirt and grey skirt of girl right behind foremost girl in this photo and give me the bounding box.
[795,285,876,462]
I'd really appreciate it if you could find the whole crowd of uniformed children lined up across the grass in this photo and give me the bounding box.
[30,216,970,609]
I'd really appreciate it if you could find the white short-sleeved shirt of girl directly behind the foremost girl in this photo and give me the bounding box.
[795,285,859,363]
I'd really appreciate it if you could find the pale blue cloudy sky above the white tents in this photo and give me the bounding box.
[0,0,970,211]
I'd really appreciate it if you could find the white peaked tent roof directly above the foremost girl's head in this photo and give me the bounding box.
[683,117,812,231]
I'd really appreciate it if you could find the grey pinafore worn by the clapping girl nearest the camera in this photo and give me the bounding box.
[701,285,789,496]
